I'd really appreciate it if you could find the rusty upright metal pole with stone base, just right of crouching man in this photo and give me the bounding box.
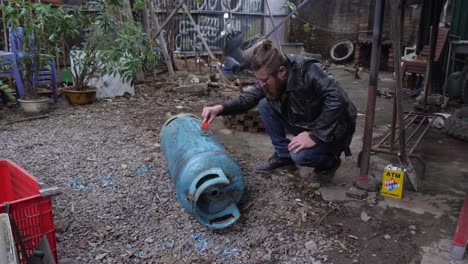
[356,0,385,191]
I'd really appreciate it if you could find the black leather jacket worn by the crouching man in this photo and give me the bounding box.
[221,55,357,155]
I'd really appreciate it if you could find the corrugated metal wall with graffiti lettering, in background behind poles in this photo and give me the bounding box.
[154,0,264,52]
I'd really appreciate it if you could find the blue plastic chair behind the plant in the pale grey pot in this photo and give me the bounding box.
[8,27,57,102]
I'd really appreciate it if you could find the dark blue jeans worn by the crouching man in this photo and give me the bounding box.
[258,98,336,170]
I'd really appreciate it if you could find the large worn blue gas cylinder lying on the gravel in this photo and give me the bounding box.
[161,114,244,229]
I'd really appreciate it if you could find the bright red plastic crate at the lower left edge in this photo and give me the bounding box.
[0,160,58,263]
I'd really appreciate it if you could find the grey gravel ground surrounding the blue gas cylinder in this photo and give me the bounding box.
[0,85,348,263]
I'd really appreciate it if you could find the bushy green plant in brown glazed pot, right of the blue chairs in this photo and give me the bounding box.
[63,1,158,104]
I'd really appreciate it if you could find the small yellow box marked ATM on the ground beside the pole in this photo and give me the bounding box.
[381,165,405,199]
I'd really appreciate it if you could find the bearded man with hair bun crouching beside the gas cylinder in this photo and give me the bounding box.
[202,40,357,182]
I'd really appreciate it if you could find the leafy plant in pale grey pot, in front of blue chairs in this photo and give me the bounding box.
[1,0,77,112]
